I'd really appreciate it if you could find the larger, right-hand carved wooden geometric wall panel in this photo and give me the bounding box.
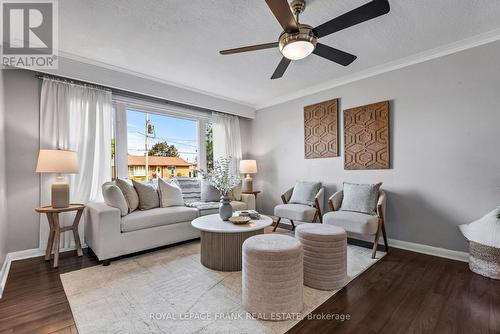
[344,101,390,170]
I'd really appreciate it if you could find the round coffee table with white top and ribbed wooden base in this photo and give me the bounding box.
[191,214,273,271]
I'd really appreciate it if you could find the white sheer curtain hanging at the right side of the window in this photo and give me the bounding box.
[212,112,241,175]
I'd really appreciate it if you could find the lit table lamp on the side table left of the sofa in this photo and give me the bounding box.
[36,150,78,208]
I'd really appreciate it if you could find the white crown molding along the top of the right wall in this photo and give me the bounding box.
[255,29,500,110]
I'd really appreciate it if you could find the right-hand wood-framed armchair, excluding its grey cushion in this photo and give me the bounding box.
[323,190,389,258]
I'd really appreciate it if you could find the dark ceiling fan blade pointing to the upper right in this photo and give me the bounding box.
[314,0,391,38]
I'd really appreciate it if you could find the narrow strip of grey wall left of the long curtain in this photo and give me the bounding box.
[4,70,40,252]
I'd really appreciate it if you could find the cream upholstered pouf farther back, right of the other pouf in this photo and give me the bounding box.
[295,224,347,290]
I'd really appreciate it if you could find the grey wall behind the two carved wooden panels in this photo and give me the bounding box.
[252,42,500,250]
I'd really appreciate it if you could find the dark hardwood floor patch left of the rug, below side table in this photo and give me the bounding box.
[0,249,98,334]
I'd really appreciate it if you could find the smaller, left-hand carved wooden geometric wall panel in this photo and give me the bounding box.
[304,99,338,159]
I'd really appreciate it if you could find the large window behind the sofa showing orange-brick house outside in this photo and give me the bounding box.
[115,103,208,181]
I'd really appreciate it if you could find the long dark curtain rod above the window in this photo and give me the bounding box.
[36,72,234,116]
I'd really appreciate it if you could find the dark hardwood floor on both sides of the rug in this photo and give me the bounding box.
[0,244,500,334]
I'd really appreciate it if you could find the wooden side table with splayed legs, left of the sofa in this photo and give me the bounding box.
[35,204,85,268]
